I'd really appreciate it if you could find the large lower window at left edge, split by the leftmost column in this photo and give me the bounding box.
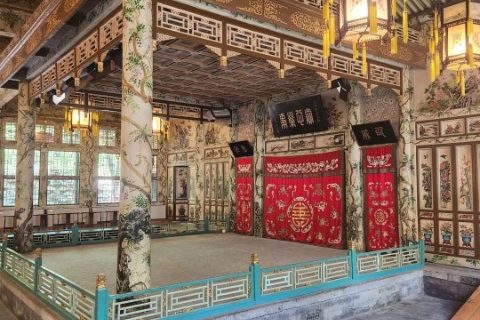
[3,149,40,207]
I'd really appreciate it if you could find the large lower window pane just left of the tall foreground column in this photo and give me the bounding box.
[97,153,120,203]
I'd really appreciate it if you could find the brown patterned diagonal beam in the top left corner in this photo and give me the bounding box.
[0,0,86,85]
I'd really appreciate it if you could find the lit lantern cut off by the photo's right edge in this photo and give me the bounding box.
[441,0,480,95]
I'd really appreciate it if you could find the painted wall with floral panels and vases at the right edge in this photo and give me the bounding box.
[414,70,480,269]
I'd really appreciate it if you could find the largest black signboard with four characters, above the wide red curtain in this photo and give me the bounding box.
[269,95,328,137]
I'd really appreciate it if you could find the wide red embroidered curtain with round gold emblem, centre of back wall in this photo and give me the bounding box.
[264,151,344,248]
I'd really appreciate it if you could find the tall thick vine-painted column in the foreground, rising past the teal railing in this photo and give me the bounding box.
[117,0,153,293]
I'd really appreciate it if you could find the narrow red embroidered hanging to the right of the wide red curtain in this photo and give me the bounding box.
[363,145,398,251]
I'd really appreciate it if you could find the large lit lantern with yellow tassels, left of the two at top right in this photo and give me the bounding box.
[340,0,408,75]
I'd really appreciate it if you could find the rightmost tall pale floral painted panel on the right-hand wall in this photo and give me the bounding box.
[455,145,473,212]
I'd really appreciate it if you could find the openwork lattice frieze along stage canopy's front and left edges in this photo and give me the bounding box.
[25,0,403,97]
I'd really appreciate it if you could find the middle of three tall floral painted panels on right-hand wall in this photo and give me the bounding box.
[436,147,453,210]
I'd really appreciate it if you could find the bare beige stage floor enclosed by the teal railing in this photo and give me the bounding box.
[35,233,347,293]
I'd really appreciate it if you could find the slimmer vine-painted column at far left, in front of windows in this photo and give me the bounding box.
[14,81,35,253]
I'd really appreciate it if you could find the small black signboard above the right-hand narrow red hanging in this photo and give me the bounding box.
[352,121,397,146]
